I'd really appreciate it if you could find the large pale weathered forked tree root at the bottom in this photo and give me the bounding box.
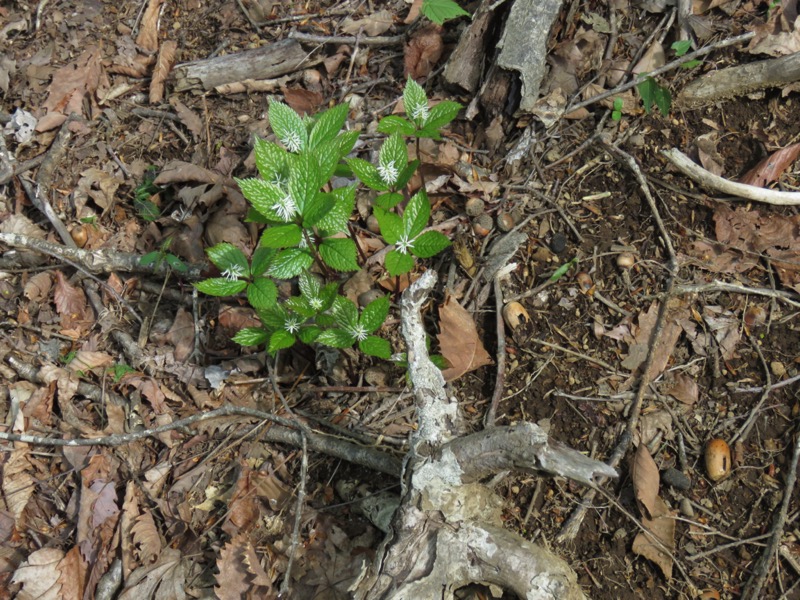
[352,271,616,600]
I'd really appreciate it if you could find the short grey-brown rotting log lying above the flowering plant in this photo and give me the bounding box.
[173,39,311,92]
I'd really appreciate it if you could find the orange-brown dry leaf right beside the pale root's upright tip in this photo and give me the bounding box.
[436,296,494,381]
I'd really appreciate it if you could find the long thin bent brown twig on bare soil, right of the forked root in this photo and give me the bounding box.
[556,138,678,543]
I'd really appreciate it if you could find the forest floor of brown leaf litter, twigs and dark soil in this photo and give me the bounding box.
[0,0,800,600]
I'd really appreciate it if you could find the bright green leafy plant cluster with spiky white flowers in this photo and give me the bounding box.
[195,79,461,359]
